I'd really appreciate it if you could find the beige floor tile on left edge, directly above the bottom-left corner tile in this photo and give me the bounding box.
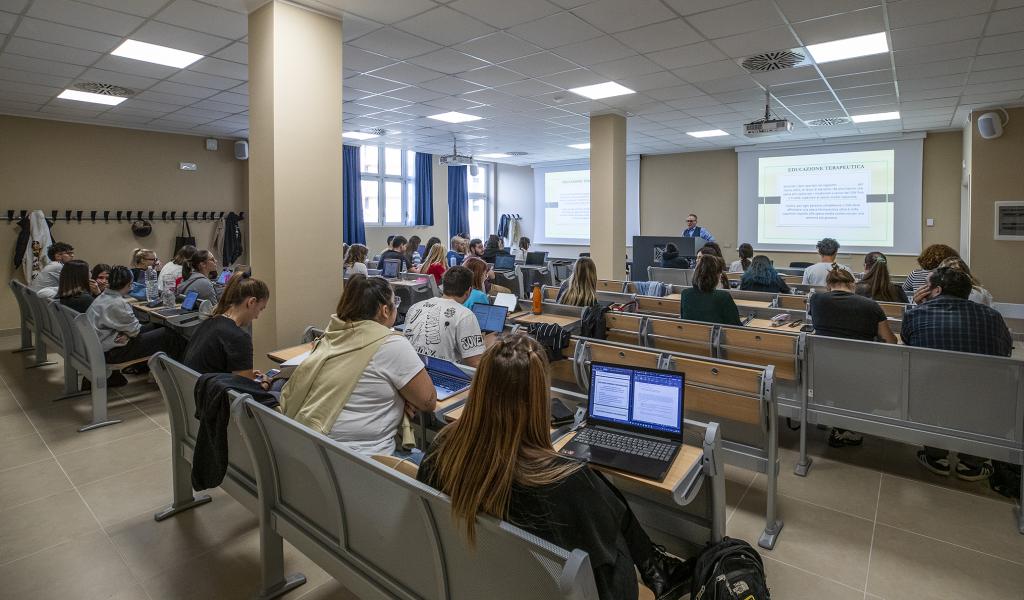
[0,491,99,564]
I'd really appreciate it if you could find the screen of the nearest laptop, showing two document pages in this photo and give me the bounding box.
[588,362,685,435]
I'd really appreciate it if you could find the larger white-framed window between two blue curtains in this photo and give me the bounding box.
[359,145,416,226]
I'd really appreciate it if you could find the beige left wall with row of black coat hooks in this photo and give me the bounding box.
[0,116,249,330]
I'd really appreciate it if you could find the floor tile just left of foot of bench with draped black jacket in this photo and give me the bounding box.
[79,459,171,526]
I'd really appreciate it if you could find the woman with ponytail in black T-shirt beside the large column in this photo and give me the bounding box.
[182,272,270,379]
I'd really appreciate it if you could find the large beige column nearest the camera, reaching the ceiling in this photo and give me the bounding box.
[249,0,342,366]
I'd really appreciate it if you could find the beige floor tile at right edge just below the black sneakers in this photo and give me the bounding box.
[879,475,1024,565]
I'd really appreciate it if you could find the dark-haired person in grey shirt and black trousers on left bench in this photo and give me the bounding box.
[86,265,185,363]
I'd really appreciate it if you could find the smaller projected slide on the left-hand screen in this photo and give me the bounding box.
[544,169,590,241]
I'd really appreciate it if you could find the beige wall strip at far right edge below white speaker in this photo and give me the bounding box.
[971,109,1024,303]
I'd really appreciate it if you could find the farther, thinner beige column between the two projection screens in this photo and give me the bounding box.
[590,115,626,280]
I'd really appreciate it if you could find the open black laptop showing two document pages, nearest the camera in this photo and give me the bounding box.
[560,362,685,481]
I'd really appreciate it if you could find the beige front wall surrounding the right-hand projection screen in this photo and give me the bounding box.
[640,131,962,274]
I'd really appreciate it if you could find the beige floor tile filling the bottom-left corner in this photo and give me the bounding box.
[0,531,144,600]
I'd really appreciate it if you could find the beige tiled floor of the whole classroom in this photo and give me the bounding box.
[0,337,1024,600]
